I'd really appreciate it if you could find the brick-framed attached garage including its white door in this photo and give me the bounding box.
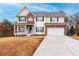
[46,25,67,35]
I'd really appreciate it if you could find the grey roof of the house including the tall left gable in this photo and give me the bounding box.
[17,7,65,17]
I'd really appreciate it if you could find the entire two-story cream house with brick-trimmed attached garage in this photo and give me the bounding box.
[14,7,67,35]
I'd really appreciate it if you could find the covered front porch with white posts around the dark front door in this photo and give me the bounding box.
[14,24,34,36]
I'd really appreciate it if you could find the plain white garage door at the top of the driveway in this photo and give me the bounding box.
[47,28,64,35]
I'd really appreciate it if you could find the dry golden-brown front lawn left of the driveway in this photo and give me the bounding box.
[0,36,44,56]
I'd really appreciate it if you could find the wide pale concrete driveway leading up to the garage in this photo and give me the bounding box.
[34,35,79,56]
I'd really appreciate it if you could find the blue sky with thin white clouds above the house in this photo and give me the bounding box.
[0,3,79,22]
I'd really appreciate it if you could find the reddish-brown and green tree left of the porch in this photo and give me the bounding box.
[1,19,13,36]
